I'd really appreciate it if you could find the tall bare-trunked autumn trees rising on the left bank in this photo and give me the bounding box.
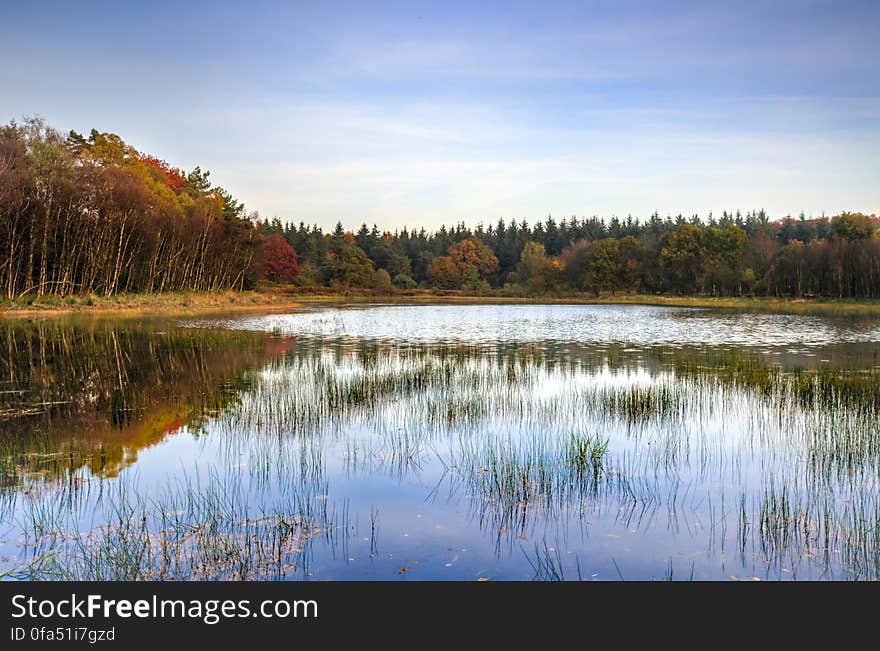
[0,119,260,298]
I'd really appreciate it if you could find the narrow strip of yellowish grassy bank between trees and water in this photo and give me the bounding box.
[0,289,880,318]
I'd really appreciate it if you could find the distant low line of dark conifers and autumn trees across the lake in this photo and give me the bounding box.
[260,210,880,298]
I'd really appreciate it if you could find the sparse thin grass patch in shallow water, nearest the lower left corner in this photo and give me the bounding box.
[13,454,348,581]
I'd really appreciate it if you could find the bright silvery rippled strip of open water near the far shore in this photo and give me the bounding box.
[192,305,880,346]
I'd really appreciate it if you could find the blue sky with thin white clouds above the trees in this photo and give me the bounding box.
[0,0,880,230]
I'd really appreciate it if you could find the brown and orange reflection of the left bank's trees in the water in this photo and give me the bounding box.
[0,320,283,486]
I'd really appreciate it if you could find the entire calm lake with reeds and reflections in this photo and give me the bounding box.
[0,304,880,580]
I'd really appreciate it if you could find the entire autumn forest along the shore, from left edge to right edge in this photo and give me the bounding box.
[0,119,880,300]
